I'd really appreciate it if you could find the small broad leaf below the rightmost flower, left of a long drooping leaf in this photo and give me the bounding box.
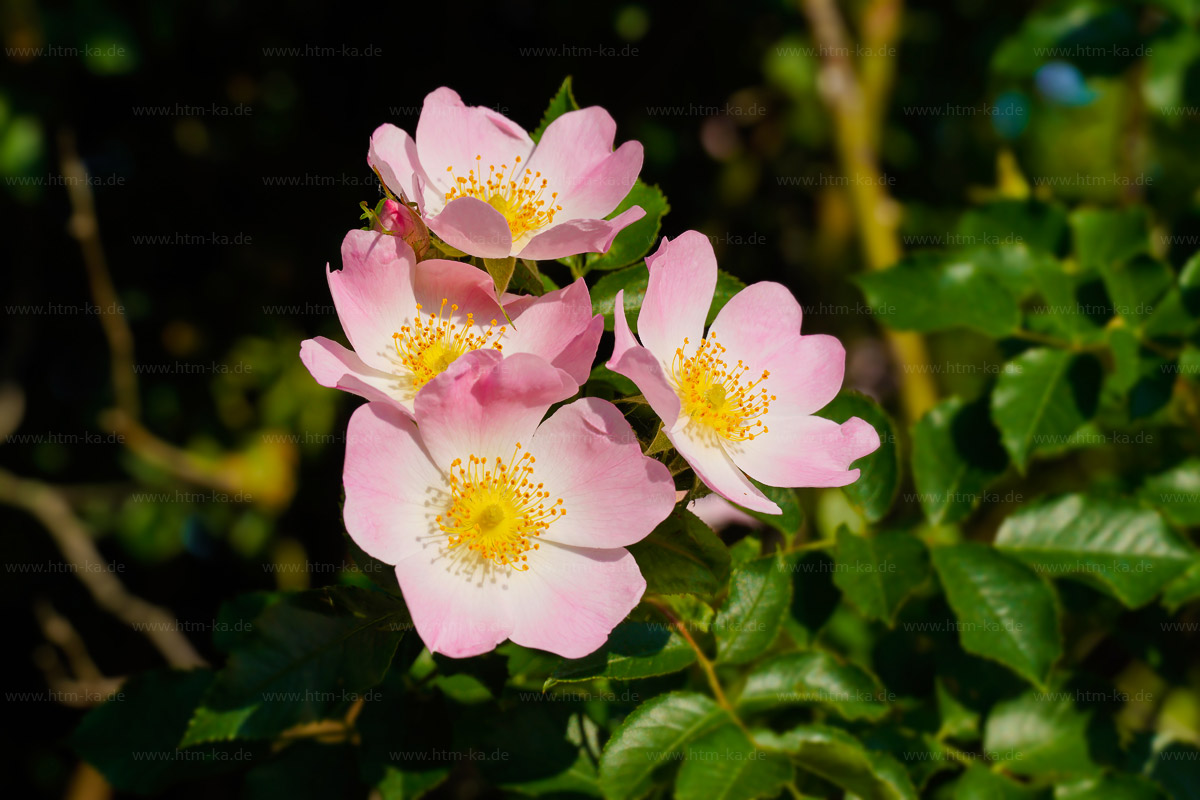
[833,525,929,627]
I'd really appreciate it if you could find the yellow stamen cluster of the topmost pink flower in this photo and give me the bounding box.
[446,156,563,241]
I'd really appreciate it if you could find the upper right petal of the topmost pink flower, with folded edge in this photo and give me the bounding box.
[528,106,642,220]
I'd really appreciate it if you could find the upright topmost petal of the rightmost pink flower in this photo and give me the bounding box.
[637,230,716,365]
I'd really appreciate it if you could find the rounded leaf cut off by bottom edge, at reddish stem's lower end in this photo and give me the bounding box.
[674,724,792,800]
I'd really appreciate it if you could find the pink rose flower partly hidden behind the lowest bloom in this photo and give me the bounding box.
[300,230,604,414]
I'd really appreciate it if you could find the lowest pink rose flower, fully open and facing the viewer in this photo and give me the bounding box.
[344,349,674,658]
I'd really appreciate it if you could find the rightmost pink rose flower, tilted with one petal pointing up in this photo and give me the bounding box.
[608,230,880,513]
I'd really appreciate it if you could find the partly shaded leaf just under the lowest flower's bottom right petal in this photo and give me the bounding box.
[546,620,696,688]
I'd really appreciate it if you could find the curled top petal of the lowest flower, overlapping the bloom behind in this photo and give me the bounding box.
[415,349,578,469]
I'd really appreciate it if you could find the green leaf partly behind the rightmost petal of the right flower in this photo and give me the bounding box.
[818,391,901,522]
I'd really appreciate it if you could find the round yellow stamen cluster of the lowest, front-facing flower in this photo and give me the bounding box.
[437,443,566,572]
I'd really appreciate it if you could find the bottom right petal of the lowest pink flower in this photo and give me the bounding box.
[509,542,646,658]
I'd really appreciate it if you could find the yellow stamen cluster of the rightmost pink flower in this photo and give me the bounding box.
[671,332,775,441]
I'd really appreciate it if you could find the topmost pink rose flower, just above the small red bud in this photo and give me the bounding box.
[367,88,646,260]
